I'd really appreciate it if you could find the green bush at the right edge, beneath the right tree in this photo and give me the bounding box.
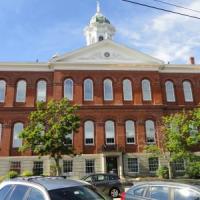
[186,162,200,178]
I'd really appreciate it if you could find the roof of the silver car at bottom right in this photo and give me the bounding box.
[129,181,200,192]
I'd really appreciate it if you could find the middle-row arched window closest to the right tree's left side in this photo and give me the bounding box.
[145,120,156,144]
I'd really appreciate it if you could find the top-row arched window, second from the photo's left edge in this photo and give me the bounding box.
[16,80,26,102]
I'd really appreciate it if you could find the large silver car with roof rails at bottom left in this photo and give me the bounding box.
[0,177,105,200]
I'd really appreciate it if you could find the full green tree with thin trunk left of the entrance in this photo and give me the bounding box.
[20,98,80,175]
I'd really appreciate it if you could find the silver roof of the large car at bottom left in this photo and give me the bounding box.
[1,177,90,190]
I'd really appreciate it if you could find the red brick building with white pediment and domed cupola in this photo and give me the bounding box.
[0,3,200,177]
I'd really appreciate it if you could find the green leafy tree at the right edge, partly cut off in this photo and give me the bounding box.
[145,108,200,179]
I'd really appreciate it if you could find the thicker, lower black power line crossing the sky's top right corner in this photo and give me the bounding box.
[122,0,200,19]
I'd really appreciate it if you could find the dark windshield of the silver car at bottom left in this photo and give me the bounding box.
[49,186,105,200]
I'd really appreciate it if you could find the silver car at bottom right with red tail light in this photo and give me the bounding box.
[121,181,200,200]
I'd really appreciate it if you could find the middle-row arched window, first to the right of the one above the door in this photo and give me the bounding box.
[125,120,135,144]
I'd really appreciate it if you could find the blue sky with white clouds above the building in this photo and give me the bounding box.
[0,0,200,64]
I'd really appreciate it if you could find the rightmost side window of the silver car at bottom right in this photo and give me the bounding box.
[174,188,200,200]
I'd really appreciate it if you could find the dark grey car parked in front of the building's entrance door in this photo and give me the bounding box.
[82,173,122,198]
